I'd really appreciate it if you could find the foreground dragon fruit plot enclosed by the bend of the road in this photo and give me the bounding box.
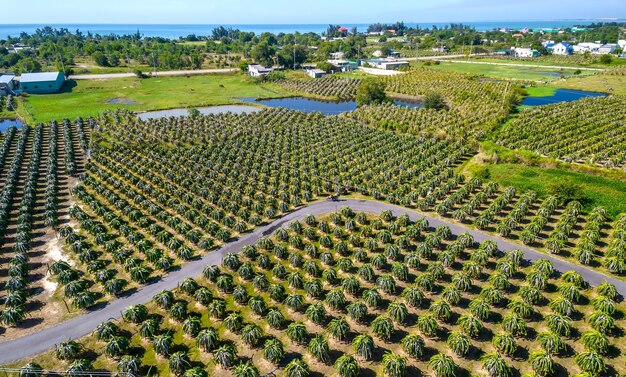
[12,207,626,377]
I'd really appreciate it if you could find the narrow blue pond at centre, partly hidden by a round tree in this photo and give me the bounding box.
[237,97,422,115]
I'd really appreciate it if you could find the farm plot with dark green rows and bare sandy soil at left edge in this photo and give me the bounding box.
[0,122,87,337]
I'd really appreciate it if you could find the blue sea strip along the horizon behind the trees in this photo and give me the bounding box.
[0,19,624,39]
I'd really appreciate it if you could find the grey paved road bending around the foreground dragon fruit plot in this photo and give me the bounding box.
[0,199,626,364]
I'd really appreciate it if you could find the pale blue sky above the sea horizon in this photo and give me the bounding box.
[8,0,626,24]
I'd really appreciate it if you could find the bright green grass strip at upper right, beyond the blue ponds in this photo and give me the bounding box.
[422,62,590,81]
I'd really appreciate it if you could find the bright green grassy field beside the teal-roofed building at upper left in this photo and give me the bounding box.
[18,74,287,122]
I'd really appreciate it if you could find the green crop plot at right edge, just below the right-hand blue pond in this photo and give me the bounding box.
[497,96,626,168]
